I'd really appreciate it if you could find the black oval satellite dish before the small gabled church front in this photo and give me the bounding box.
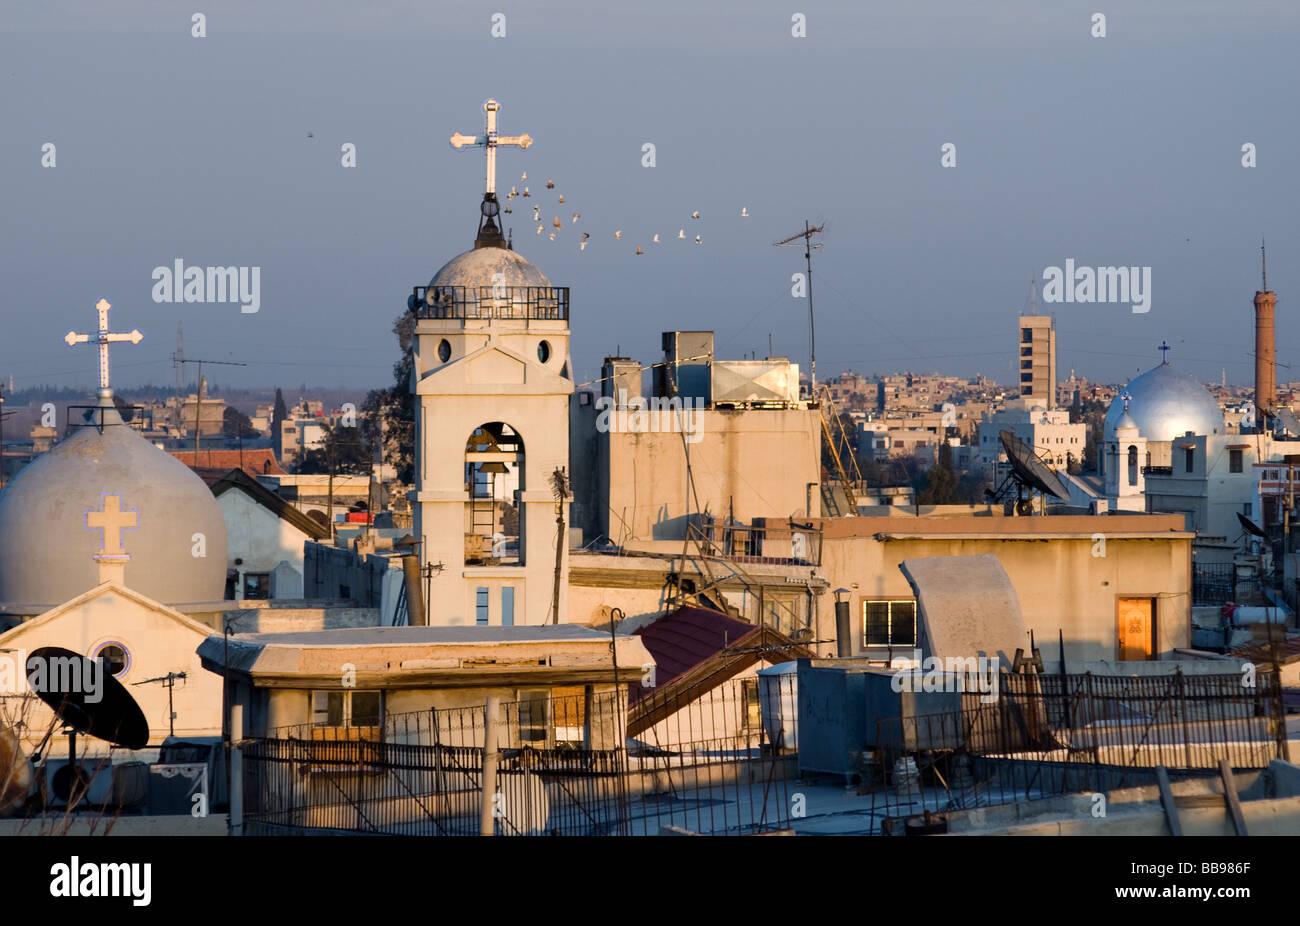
[27,646,150,749]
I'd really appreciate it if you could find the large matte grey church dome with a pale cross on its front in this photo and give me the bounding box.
[0,398,226,613]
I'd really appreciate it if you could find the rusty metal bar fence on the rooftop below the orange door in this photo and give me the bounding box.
[868,672,1287,832]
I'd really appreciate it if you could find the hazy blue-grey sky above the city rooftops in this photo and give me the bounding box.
[0,0,1300,390]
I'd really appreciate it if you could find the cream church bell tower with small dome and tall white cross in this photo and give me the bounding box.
[407,100,573,626]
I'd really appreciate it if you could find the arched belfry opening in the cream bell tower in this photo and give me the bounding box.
[465,421,527,566]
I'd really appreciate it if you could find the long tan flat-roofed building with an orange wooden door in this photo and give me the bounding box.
[816,514,1195,665]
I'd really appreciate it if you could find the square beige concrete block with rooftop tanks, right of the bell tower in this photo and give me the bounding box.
[569,332,822,549]
